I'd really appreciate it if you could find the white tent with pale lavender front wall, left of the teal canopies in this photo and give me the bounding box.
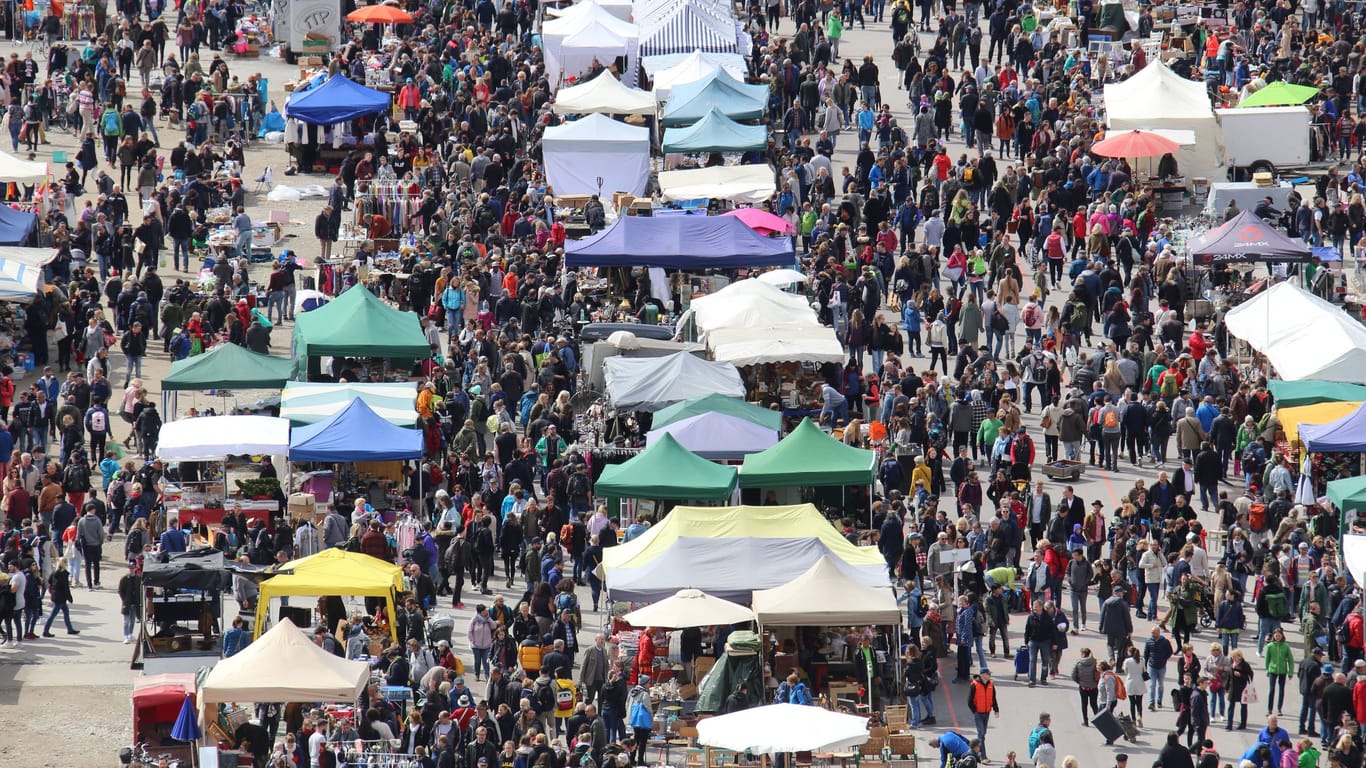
[541,115,650,197]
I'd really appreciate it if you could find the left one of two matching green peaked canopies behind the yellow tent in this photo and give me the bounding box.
[593,435,736,502]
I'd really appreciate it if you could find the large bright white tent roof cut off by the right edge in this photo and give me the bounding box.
[1224,280,1366,384]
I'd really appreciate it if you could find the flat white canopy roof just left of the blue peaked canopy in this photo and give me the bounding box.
[157,415,290,456]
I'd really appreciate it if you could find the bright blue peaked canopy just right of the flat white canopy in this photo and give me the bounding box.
[290,398,422,462]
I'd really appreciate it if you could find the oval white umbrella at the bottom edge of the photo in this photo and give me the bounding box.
[697,704,867,754]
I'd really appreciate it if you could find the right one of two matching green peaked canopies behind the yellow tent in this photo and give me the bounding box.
[740,418,874,488]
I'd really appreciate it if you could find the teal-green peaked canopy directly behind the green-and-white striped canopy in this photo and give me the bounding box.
[294,288,432,377]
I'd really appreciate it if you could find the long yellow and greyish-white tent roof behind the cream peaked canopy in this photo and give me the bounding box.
[602,504,888,603]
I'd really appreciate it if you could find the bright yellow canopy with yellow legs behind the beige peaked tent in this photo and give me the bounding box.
[255,549,403,640]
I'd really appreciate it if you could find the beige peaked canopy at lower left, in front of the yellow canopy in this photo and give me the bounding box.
[199,620,370,707]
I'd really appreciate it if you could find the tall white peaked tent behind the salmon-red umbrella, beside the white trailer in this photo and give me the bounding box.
[1105,61,1224,179]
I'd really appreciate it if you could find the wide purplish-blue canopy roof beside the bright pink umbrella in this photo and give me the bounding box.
[564,216,794,269]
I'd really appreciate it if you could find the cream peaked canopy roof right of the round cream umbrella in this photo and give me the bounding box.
[753,556,902,627]
